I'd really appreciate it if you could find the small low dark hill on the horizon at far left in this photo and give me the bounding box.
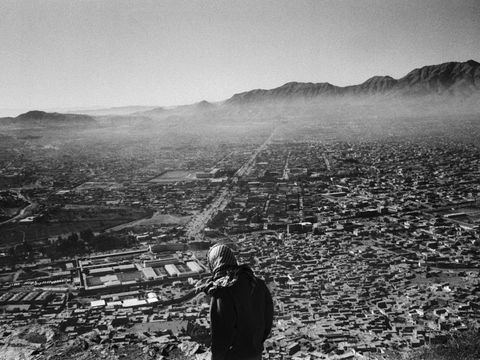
[0,110,96,127]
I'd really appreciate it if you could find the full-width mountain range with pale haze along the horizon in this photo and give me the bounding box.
[0,60,480,127]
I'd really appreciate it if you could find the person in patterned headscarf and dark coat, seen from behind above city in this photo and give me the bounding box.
[200,244,273,360]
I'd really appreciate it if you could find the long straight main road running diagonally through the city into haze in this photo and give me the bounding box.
[186,128,275,240]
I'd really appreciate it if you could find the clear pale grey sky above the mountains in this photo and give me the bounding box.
[0,0,480,109]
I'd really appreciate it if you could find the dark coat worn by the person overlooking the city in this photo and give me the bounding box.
[210,270,273,360]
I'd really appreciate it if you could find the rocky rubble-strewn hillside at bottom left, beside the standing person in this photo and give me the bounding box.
[0,324,210,360]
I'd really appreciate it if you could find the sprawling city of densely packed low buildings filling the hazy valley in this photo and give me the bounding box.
[0,90,480,359]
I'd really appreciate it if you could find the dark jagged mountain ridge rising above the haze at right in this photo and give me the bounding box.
[225,60,480,105]
